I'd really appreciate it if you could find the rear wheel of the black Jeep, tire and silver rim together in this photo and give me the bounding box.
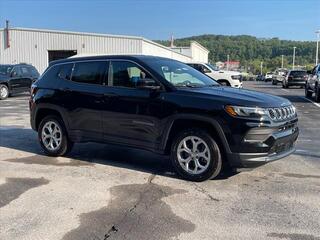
[38,115,73,157]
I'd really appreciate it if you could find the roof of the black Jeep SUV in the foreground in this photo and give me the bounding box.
[49,55,176,66]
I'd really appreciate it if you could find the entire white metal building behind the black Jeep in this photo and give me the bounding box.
[0,28,209,73]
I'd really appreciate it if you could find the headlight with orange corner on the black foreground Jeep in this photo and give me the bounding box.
[225,105,269,119]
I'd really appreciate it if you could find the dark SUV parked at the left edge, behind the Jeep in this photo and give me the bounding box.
[0,64,39,100]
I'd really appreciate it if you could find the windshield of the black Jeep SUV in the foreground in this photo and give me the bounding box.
[152,59,219,87]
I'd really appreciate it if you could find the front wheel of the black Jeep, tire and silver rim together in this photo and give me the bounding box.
[171,128,222,182]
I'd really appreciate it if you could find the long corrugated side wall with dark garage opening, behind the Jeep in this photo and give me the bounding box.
[0,29,142,72]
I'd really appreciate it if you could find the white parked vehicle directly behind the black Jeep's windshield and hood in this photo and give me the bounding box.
[188,63,242,88]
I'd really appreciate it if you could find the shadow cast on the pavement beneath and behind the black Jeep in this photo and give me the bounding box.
[0,126,237,180]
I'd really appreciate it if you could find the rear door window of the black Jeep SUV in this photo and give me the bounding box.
[72,61,107,84]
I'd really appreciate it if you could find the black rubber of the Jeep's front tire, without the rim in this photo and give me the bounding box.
[171,129,222,182]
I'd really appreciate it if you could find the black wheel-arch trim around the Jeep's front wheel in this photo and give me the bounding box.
[159,113,231,153]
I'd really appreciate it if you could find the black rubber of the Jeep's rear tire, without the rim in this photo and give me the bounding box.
[38,115,72,157]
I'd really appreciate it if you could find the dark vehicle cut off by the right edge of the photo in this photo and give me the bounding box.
[305,64,320,102]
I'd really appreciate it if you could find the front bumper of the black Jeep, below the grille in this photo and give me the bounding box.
[228,119,299,168]
